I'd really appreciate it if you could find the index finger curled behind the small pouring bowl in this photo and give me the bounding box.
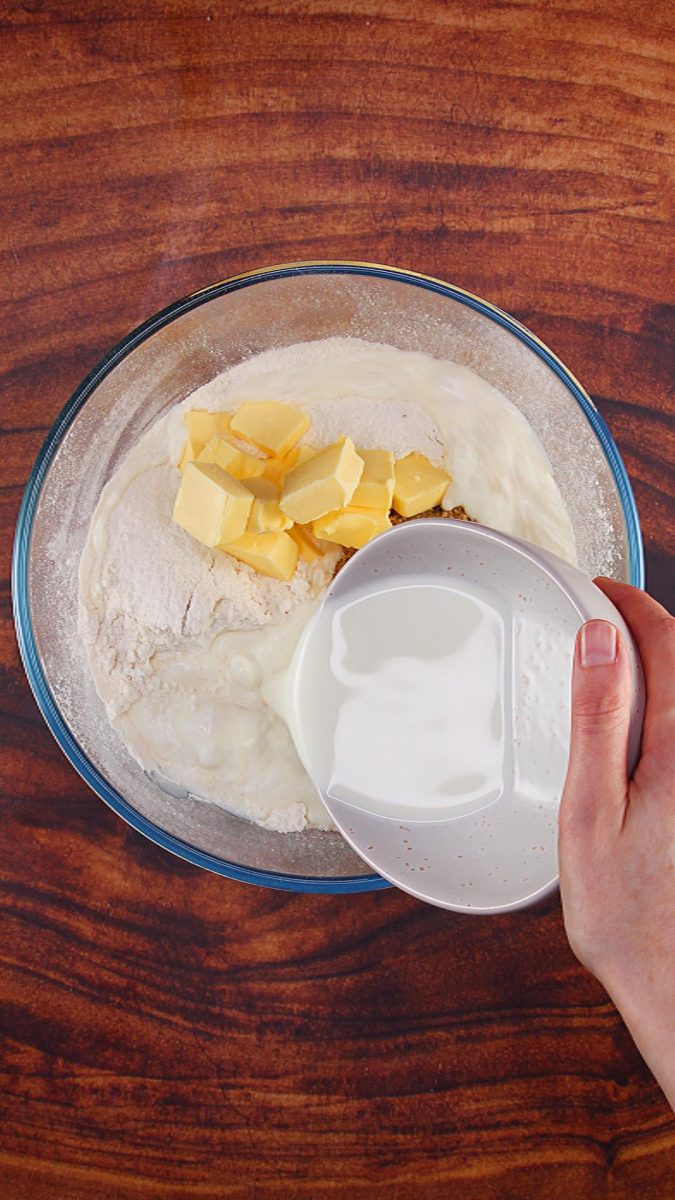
[595,576,675,757]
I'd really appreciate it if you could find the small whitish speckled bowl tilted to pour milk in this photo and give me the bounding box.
[282,518,644,913]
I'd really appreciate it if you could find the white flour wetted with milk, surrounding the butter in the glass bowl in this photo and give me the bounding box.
[80,338,575,832]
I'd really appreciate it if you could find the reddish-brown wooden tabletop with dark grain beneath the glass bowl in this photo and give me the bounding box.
[0,0,675,1200]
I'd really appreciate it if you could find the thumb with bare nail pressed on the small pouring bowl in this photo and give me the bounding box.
[561,620,631,828]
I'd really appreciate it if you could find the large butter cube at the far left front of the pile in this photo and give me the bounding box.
[173,462,253,546]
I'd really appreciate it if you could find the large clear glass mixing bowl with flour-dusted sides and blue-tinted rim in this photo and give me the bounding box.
[12,262,644,892]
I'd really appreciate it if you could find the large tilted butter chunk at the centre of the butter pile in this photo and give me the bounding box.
[280,438,363,524]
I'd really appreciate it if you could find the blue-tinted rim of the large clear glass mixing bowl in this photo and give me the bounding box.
[12,259,645,894]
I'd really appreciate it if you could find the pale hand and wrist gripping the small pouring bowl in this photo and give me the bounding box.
[560,580,675,1108]
